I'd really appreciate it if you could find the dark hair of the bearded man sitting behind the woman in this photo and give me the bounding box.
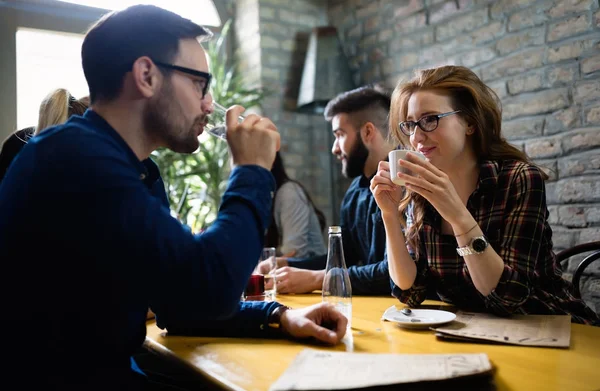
[324,86,391,137]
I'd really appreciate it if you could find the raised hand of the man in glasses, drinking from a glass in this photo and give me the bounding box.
[225,105,280,171]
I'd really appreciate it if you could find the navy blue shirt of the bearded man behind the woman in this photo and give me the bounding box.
[288,175,391,295]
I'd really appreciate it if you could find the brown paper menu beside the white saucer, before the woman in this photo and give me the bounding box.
[435,311,571,348]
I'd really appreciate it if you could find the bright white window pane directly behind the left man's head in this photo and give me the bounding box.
[16,28,89,129]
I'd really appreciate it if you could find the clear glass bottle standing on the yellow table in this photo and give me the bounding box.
[322,226,352,328]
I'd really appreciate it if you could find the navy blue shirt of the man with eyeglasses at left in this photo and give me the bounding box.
[0,110,279,389]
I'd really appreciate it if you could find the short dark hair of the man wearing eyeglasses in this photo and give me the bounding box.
[81,5,212,103]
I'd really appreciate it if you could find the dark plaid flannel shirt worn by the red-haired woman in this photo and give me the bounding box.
[392,160,598,323]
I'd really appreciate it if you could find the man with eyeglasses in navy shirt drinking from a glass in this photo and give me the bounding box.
[0,5,347,390]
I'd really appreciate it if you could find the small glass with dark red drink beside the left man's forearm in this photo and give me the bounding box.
[243,247,277,301]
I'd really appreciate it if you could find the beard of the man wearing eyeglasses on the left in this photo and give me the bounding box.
[142,78,206,153]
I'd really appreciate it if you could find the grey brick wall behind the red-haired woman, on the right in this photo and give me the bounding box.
[328,0,600,309]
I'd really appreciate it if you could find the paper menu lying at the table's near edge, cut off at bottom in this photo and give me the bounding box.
[269,349,492,391]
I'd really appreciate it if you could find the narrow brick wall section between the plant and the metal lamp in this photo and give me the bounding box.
[235,0,347,225]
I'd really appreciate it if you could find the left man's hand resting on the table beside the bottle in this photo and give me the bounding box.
[281,303,348,344]
